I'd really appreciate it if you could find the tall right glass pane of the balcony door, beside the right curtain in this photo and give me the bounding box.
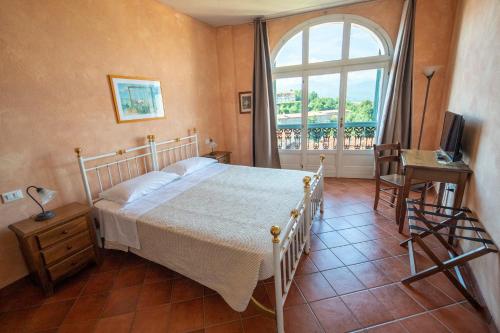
[344,68,383,150]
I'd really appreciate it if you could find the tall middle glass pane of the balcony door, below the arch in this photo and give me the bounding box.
[307,74,340,150]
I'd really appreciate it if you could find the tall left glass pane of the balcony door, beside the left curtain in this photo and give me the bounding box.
[274,77,302,149]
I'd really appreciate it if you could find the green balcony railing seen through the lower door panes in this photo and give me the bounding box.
[276,121,377,150]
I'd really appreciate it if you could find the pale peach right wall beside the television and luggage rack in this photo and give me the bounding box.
[446,0,500,327]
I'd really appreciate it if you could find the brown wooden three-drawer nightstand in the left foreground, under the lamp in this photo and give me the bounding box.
[9,202,99,296]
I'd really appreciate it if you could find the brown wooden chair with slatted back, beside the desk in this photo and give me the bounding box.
[373,143,427,224]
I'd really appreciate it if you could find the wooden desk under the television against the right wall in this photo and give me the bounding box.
[396,149,472,237]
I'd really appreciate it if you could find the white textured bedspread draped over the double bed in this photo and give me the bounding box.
[95,166,312,311]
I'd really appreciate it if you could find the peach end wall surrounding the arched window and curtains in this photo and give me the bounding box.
[217,0,456,165]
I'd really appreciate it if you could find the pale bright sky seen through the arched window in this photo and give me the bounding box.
[276,22,383,102]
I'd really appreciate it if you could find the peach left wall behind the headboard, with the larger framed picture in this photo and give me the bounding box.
[0,0,224,287]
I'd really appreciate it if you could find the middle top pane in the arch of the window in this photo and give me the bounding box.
[309,22,344,63]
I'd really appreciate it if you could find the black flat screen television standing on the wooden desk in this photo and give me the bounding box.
[439,111,465,162]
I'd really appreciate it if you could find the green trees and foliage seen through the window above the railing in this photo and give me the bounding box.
[277,90,376,122]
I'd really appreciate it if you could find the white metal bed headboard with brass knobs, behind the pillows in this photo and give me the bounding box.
[75,128,199,206]
